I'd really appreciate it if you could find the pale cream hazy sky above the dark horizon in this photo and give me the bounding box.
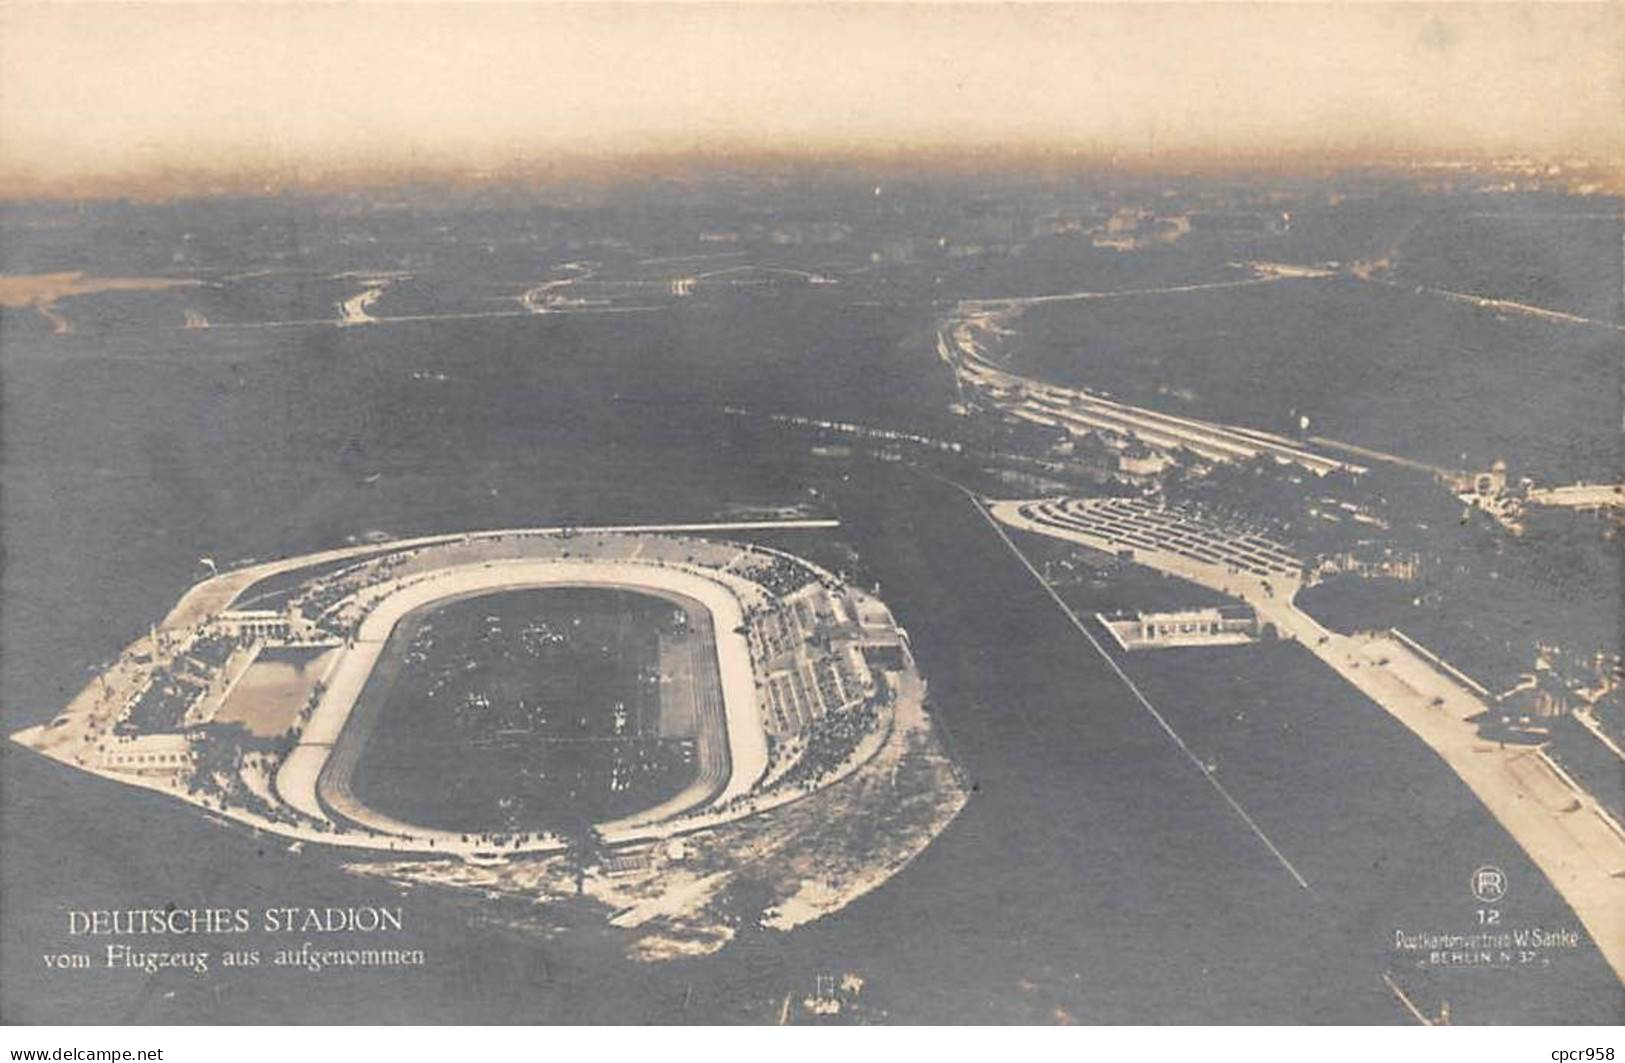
[0,0,1625,193]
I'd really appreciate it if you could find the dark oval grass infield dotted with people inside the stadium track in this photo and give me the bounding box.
[354,587,699,832]
